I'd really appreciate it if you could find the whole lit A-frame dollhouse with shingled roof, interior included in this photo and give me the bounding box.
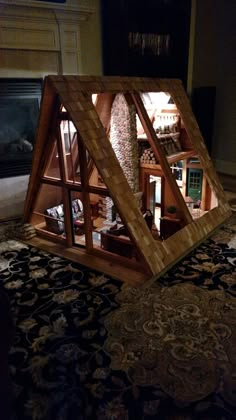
[24,76,230,283]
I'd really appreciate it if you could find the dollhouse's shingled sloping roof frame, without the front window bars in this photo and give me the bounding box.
[24,76,231,282]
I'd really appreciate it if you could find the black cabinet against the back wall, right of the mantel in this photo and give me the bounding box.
[101,0,191,85]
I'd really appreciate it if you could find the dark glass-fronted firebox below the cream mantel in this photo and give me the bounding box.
[0,78,42,178]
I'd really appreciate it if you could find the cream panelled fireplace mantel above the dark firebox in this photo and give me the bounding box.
[0,0,99,77]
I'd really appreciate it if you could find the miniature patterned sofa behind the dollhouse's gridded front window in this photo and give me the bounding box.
[44,198,83,235]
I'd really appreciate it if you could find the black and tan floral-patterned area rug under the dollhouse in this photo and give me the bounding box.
[0,216,236,420]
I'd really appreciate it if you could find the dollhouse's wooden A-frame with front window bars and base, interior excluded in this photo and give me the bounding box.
[24,76,231,284]
